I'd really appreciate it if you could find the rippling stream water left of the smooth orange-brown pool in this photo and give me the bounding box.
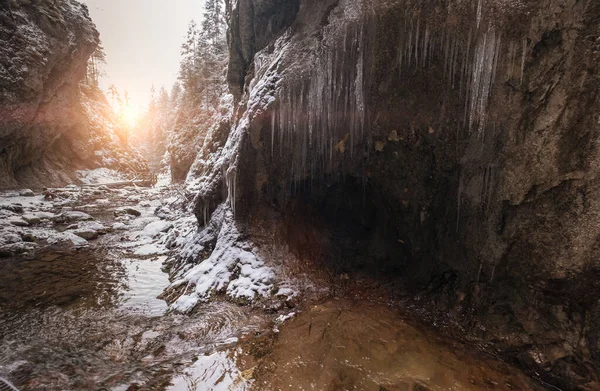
[0,251,264,390]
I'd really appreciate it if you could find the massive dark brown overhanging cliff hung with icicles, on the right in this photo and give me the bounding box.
[185,0,600,388]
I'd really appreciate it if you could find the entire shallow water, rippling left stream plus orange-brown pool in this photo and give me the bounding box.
[0,188,538,391]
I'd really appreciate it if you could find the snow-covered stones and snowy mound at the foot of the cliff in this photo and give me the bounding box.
[0,169,281,313]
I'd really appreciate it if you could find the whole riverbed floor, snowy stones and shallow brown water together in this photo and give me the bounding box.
[0,173,552,391]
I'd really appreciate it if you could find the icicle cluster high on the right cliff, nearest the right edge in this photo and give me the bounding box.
[398,16,528,139]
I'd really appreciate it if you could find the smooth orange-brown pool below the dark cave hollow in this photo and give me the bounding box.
[245,300,541,391]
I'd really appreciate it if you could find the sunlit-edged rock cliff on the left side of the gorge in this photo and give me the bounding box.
[0,0,143,187]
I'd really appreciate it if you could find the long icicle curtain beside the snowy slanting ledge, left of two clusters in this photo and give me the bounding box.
[270,22,365,188]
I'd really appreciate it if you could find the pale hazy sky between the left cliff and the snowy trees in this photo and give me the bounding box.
[80,0,204,112]
